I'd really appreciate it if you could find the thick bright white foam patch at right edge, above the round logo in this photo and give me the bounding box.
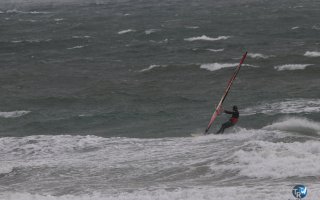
[220,141,320,178]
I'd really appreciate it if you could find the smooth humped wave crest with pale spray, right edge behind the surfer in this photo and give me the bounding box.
[264,117,320,135]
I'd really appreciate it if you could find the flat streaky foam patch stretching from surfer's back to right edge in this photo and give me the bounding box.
[241,99,320,115]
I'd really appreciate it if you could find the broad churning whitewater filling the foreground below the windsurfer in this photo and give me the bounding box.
[0,134,320,200]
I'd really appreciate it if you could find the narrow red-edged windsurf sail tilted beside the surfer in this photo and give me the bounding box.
[205,52,247,134]
